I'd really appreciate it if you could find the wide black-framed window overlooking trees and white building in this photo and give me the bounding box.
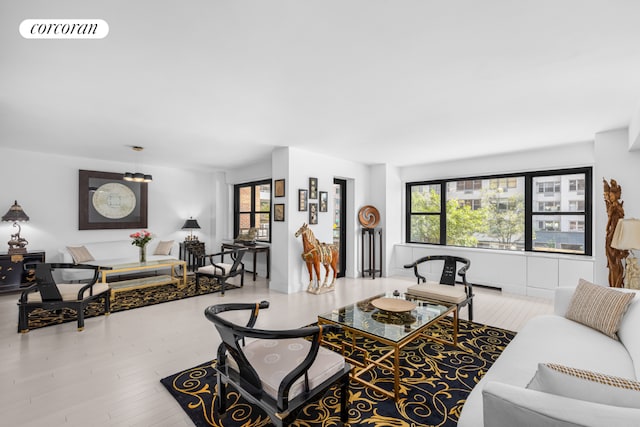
[406,168,591,255]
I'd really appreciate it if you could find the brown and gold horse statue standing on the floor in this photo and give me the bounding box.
[295,223,339,294]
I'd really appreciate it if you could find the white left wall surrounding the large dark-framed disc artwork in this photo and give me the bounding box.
[0,148,215,261]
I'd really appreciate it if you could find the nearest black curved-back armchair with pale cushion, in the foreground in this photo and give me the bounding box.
[205,301,351,427]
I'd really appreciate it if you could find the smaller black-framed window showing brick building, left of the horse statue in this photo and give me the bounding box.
[233,180,271,242]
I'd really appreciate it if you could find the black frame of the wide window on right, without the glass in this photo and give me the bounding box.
[405,166,593,256]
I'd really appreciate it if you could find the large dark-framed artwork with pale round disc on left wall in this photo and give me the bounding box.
[78,169,148,230]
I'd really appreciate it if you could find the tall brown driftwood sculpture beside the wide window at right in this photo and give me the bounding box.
[602,179,629,288]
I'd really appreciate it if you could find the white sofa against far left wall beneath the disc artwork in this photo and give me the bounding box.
[59,240,179,281]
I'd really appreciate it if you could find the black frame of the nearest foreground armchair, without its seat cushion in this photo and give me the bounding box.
[205,301,351,427]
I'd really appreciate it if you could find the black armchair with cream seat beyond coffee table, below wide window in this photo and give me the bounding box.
[404,255,474,321]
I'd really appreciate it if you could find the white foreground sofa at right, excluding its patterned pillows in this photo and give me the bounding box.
[458,288,640,427]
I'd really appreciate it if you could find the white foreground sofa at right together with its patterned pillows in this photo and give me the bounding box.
[458,280,640,427]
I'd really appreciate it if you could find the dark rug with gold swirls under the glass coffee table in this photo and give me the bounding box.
[161,320,515,427]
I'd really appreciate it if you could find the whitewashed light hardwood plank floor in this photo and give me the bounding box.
[0,276,552,427]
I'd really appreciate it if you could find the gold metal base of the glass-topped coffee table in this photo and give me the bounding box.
[318,305,458,402]
